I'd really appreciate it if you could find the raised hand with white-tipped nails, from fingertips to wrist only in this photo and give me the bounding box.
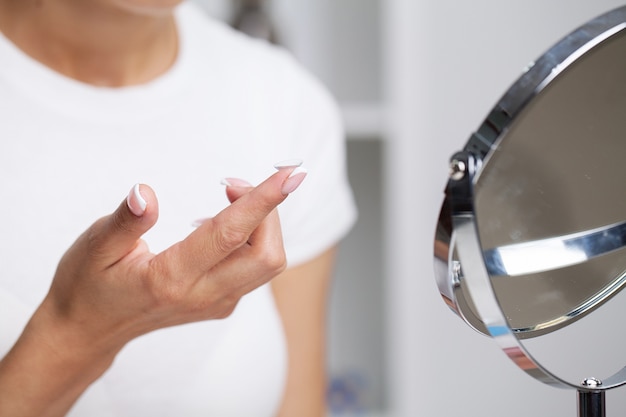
[44,166,304,349]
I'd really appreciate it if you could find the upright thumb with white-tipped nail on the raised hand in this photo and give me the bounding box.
[87,184,159,267]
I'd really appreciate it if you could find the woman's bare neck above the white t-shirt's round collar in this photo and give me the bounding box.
[0,0,178,87]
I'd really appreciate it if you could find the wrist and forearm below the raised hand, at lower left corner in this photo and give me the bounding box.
[0,307,119,417]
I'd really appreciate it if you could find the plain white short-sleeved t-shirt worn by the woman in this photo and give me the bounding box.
[0,4,356,417]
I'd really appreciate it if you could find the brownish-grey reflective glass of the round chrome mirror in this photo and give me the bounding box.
[474,27,626,330]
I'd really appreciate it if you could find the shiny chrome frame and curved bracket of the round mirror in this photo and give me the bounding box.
[434,6,626,400]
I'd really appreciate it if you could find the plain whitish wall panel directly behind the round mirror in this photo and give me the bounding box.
[384,0,626,417]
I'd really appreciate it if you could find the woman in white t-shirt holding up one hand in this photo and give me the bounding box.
[0,0,355,417]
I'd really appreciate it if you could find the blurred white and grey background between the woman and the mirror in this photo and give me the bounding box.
[194,0,626,417]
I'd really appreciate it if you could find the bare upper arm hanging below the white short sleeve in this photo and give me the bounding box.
[271,248,336,417]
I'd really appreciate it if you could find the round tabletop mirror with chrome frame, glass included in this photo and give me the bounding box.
[435,7,626,389]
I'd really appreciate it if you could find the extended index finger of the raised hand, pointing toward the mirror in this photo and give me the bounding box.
[167,167,306,274]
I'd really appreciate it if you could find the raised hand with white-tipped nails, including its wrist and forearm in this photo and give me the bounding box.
[0,167,304,417]
